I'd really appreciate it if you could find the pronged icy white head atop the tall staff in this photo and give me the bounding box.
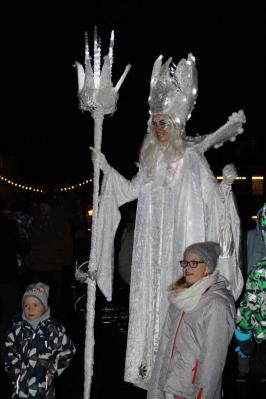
[75,28,131,114]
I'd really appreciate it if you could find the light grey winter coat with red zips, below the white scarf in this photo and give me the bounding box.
[147,275,235,399]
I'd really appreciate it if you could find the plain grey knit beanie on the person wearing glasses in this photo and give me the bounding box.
[184,241,220,273]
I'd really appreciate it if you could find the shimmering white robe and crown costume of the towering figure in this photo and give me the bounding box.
[94,54,245,389]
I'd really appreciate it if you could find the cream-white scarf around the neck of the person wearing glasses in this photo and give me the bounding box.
[169,271,219,312]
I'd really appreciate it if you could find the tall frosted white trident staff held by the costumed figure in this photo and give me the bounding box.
[75,28,130,399]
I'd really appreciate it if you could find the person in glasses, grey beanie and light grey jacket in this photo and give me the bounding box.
[147,241,235,399]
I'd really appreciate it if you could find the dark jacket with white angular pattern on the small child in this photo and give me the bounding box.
[4,314,75,399]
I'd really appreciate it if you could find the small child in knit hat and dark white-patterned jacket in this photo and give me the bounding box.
[4,283,75,399]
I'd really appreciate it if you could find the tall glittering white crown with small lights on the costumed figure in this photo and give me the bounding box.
[148,54,198,127]
